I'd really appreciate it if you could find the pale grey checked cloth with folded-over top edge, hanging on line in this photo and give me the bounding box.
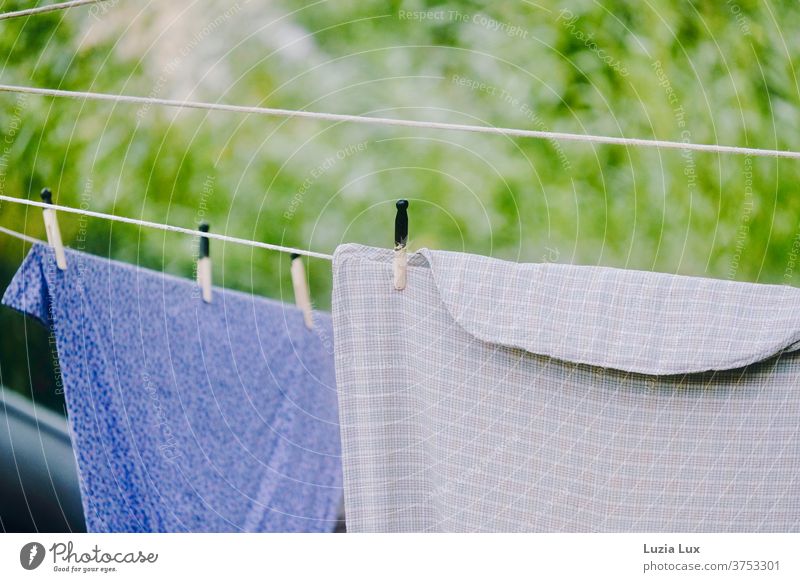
[333,245,800,532]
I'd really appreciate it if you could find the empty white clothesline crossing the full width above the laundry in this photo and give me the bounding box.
[0,85,800,159]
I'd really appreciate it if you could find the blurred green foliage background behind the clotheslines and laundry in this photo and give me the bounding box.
[0,0,800,407]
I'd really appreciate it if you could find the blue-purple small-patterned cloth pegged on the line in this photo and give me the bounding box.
[3,245,342,532]
